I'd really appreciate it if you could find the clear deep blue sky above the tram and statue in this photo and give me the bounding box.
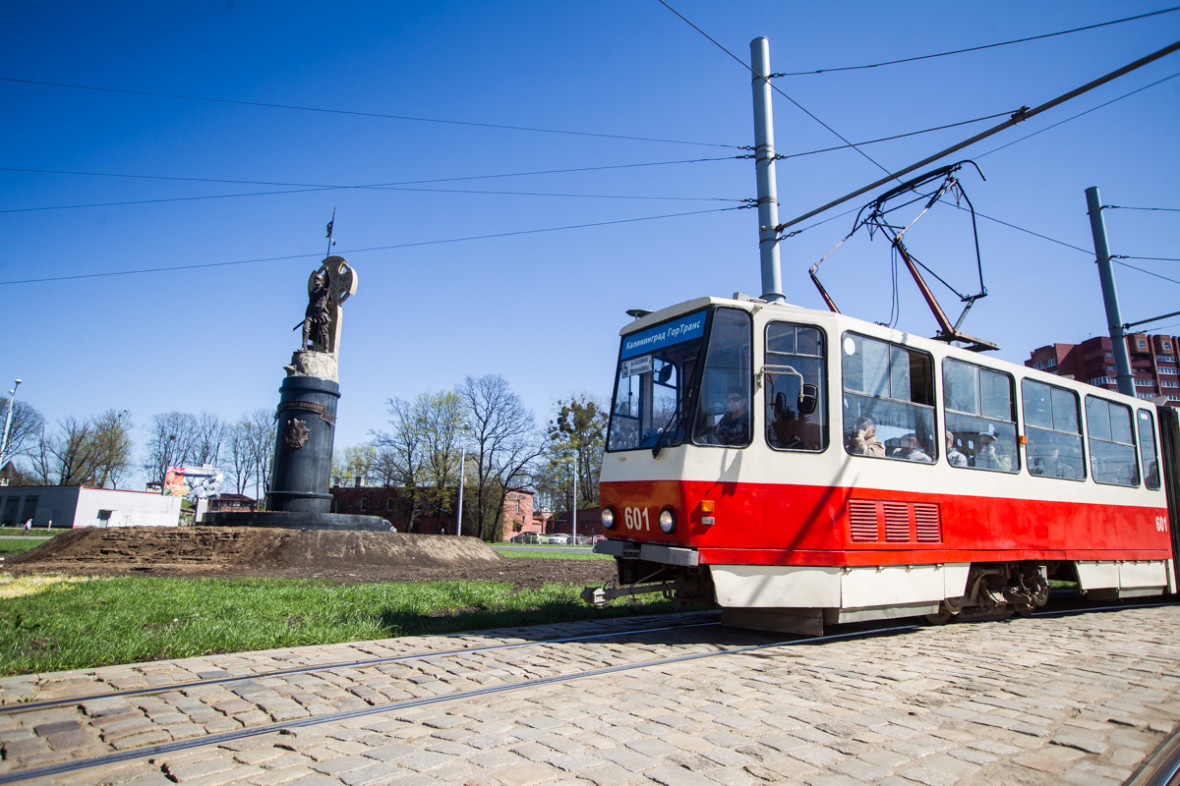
[0,0,1180,483]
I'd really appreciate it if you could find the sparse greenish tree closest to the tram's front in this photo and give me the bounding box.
[546,393,610,507]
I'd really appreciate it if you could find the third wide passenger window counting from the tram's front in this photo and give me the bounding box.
[1021,379,1086,480]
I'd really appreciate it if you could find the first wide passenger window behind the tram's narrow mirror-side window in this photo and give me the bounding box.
[843,333,939,464]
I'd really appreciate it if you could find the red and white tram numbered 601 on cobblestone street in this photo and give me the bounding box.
[596,295,1176,633]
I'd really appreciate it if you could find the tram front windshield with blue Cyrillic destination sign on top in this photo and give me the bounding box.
[607,309,708,451]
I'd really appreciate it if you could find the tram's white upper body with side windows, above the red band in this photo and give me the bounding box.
[602,296,1166,507]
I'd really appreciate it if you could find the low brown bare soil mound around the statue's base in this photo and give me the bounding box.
[4,526,615,587]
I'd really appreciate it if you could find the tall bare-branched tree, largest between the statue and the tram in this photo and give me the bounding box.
[459,374,545,541]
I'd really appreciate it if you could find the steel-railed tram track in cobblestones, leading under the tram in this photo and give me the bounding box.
[0,604,1158,785]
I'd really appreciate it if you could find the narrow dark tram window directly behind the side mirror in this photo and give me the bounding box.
[765,322,827,451]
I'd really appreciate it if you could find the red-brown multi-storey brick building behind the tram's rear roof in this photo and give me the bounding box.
[1024,333,1180,407]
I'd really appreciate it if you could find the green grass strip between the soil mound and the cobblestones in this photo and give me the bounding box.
[0,572,679,676]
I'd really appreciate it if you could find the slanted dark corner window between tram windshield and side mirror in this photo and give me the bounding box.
[693,308,753,447]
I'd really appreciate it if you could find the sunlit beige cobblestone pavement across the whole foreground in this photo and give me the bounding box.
[0,605,1180,786]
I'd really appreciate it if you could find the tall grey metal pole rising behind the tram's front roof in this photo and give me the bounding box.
[749,37,786,301]
